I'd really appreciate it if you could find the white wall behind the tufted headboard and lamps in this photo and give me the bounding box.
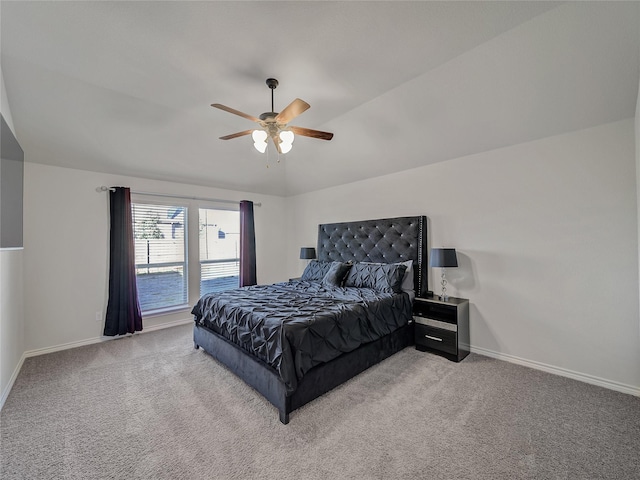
[287,119,640,394]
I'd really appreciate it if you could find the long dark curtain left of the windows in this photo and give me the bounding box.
[104,187,142,336]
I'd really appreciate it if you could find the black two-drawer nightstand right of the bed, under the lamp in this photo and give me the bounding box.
[413,297,469,362]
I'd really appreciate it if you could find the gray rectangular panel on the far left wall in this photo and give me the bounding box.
[0,114,24,248]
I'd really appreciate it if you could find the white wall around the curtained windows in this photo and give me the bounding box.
[24,159,286,351]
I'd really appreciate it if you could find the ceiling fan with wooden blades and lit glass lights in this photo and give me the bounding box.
[211,78,333,153]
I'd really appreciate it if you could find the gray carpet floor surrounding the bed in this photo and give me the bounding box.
[0,325,640,480]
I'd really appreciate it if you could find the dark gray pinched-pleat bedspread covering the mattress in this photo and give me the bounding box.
[191,282,411,391]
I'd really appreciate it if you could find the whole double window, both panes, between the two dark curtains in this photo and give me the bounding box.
[132,197,240,315]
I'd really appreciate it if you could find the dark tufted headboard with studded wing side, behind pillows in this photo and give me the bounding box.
[318,216,428,297]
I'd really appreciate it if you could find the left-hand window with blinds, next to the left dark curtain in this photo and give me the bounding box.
[132,203,189,313]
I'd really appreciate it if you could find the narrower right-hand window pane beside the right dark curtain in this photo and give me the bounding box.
[199,208,240,295]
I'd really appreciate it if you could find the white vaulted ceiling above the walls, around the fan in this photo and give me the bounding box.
[0,0,640,195]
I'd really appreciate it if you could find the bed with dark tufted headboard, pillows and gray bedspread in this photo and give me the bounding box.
[192,216,427,424]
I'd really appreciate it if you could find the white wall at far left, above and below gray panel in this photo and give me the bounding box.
[0,64,24,408]
